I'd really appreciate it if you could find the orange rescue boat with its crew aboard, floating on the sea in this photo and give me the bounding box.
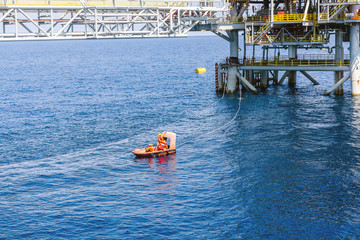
[132,132,176,158]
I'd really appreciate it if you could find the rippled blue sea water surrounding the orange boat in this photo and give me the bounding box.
[0,36,360,239]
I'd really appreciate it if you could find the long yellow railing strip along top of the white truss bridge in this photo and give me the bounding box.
[0,0,185,7]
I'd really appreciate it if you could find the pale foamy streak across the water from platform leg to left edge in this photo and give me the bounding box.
[0,87,226,168]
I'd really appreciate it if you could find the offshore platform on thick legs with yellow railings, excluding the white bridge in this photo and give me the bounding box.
[197,0,360,95]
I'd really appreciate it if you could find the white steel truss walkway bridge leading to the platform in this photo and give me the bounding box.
[0,0,226,41]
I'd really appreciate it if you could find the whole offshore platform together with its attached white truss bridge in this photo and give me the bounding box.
[0,0,360,95]
